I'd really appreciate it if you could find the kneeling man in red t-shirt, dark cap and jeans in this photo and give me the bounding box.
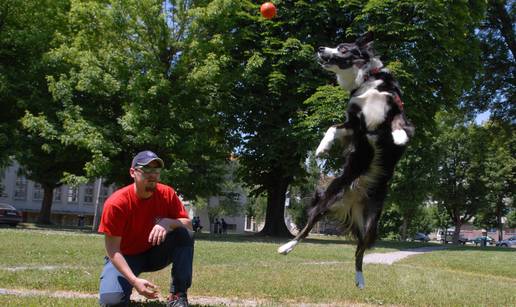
[99,151,194,306]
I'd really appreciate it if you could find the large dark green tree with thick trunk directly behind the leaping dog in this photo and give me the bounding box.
[184,0,484,236]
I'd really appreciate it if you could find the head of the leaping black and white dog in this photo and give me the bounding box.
[317,32,376,90]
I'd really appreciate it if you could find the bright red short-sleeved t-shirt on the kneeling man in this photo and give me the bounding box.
[99,183,188,255]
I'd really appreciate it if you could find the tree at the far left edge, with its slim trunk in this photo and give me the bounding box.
[0,0,97,224]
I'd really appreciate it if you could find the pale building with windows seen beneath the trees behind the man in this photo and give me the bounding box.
[0,161,292,233]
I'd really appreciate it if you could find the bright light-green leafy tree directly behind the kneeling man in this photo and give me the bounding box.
[30,0,230,199]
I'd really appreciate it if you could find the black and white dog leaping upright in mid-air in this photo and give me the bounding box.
[278,33,414,289]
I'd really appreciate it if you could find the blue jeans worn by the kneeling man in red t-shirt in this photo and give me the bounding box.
[99,227,194,306]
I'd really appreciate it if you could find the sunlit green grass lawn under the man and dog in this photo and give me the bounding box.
[0,228,516,306]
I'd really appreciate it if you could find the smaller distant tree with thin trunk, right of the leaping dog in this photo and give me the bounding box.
[431,112,488,243]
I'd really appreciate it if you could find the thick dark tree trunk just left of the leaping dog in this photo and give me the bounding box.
[259,180,292,238]
